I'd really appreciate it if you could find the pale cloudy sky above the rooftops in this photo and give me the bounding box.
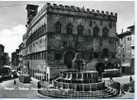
[0,1,135,56]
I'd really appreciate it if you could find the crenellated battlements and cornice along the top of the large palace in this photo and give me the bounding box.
[29,3,117,32]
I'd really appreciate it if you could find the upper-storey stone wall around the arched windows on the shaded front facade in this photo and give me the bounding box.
[47,12,116,37]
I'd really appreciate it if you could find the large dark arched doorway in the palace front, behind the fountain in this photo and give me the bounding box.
[64,50,75,68]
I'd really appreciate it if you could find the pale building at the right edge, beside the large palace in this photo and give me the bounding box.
[118,25,135,74]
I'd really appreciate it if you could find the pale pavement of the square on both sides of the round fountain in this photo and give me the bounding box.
[0,76,134,99]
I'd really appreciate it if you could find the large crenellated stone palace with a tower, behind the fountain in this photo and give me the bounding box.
[23,3,118,80]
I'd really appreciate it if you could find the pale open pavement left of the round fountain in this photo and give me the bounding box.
[0,79,47,98]
